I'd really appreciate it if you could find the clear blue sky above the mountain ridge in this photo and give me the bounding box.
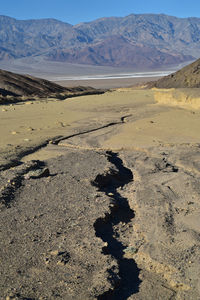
[0,0,200,24]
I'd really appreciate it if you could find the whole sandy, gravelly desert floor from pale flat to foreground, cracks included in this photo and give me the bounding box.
[0,88,200,300]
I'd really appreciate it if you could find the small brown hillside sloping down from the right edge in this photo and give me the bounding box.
[150,59,200,88]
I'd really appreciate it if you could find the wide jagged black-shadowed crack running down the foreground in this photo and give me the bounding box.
[93,151,141,300]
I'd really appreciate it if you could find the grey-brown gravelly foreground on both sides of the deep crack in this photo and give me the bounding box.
[0,125,200,300]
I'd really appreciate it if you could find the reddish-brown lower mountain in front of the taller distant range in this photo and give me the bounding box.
[48,35,192,68]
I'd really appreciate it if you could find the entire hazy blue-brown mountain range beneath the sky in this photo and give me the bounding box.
[0,14,200,69]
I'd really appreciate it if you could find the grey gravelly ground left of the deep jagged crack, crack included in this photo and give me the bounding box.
[0,151,140,299]
